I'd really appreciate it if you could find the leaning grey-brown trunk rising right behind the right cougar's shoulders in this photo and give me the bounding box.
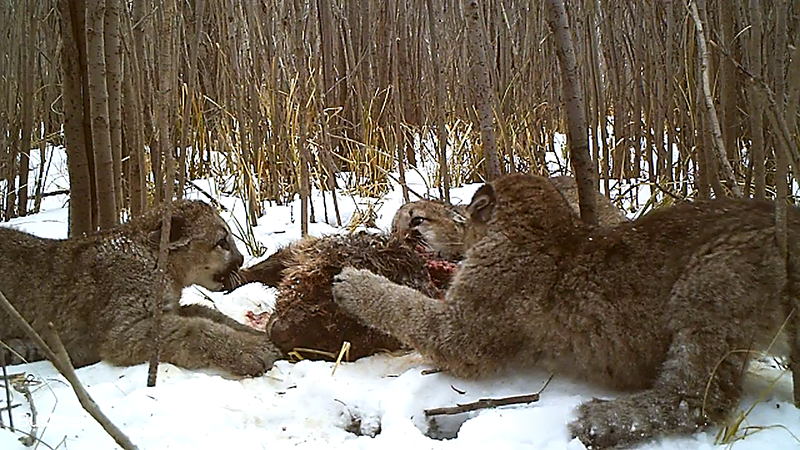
[546,0,597,224]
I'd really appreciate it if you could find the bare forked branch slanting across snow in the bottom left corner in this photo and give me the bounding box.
[0,292,137,450]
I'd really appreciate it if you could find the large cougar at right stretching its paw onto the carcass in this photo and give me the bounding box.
[333,174,800,448]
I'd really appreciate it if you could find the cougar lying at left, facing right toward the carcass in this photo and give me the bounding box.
[0,200,279,375]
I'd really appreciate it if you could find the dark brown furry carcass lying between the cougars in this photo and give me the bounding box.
[253,233,440,359]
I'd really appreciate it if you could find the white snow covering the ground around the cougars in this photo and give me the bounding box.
[0,153,800,450]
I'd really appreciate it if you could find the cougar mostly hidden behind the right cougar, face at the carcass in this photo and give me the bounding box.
[392,176,628,261]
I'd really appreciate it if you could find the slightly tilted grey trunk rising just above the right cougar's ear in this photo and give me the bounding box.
[466,0,500,181]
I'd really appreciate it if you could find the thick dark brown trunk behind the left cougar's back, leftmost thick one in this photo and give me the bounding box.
[58,0,93,236]
